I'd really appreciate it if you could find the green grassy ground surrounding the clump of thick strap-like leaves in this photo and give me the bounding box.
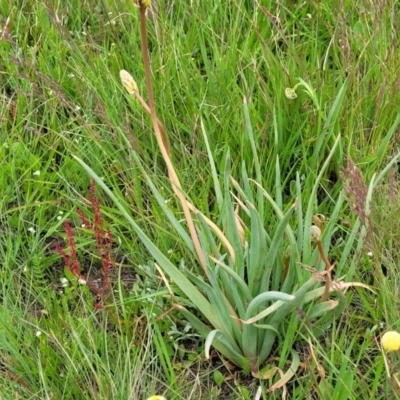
[0,0,400,399]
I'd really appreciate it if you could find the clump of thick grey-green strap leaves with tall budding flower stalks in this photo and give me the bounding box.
[75,1,382,391]
